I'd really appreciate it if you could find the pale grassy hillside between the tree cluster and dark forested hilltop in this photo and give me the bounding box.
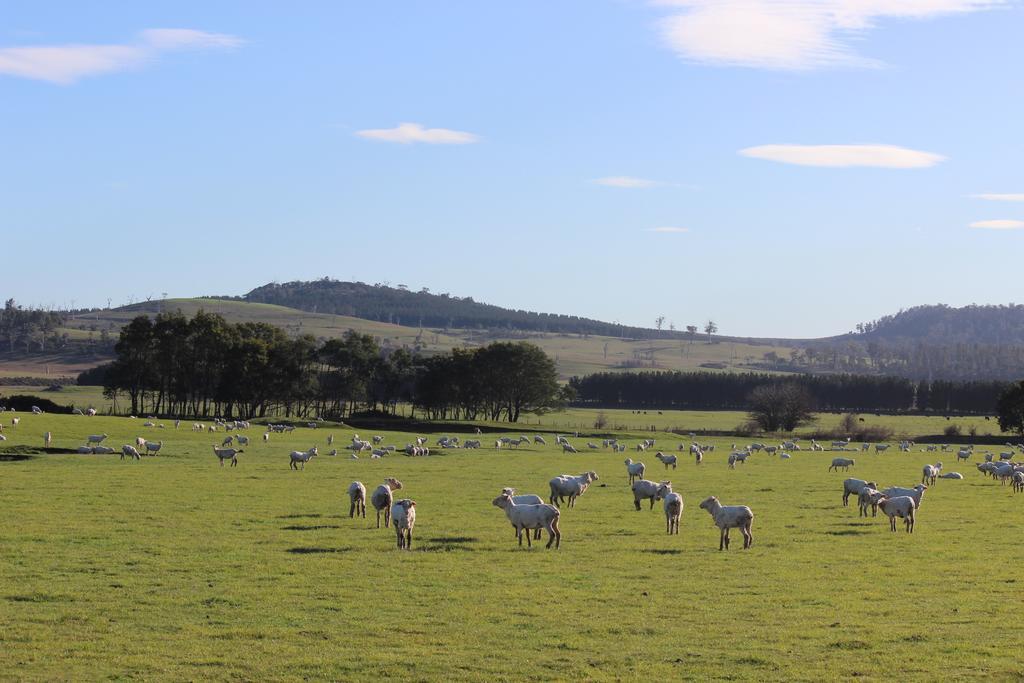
[9,298,792,379]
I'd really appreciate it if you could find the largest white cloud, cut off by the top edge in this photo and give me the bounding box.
[653,0,1008,70]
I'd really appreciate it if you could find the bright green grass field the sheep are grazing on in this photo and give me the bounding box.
[0,414,1024,681]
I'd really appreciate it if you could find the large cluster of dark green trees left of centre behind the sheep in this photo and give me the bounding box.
[96,311,563,422]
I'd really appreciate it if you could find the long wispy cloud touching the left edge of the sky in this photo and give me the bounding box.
[0,29,243,85]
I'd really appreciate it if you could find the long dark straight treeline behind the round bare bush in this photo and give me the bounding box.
[569,372,1009,415]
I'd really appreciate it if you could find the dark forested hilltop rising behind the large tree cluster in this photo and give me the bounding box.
[239,279,700,339]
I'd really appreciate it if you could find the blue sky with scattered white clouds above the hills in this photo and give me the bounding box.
[0,0,1024,337]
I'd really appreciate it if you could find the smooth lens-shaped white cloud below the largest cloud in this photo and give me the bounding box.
[739,144,945,168]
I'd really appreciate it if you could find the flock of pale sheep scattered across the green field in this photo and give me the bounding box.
[9,409,1024,550]
